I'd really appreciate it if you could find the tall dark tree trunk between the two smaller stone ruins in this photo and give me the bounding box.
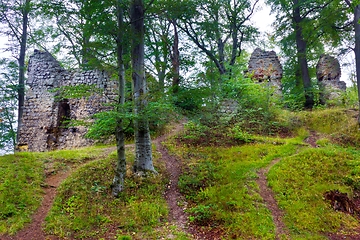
[293,0,314,108]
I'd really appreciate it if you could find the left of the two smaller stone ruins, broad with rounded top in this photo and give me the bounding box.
[248,48,283,91]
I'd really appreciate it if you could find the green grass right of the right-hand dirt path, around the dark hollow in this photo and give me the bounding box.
[268,146,360,239]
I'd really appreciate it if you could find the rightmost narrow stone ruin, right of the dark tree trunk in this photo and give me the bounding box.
[316,54,346,103]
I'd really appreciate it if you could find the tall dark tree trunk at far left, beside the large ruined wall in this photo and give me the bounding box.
[16,0,30,140]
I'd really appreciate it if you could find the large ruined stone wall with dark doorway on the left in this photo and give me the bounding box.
[18,50,117,151]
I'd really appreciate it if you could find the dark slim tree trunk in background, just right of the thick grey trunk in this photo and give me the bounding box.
[170,19,180,93]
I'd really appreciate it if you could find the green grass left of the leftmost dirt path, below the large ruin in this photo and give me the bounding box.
[0,147,109,235]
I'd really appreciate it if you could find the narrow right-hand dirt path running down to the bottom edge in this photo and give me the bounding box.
[256,159,289,239]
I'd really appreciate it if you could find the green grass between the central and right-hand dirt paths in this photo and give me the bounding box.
[177,144,297,239]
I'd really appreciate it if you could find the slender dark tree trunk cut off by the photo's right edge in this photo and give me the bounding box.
[354,5,360,125]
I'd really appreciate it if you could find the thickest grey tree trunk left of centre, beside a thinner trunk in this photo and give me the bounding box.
[130,0,156,174]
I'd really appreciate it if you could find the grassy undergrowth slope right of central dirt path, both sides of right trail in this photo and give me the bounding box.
[168,108,360,239]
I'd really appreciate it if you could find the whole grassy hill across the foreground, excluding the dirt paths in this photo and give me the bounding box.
[0,108,360,239]
